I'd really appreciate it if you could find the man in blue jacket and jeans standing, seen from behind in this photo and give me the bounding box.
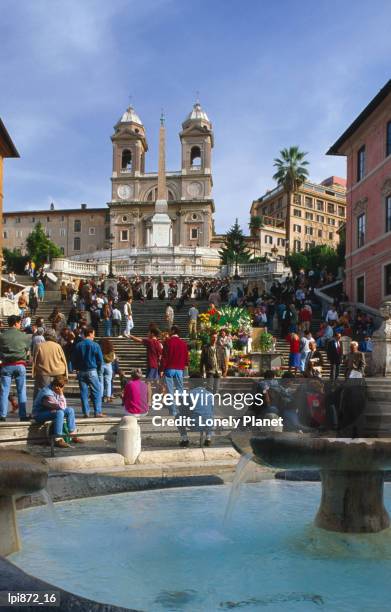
[72,327,103,418]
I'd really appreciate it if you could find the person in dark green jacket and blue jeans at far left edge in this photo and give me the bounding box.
[0,315,31,421]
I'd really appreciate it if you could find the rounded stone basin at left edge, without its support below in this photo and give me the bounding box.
[0,450,48,497]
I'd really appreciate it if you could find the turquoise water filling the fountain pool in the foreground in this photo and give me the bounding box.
[11,480,391,612]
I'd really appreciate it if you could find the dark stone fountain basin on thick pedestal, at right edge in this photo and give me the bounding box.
[247,434,391,533]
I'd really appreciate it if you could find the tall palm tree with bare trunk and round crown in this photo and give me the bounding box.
[273,147,308,257]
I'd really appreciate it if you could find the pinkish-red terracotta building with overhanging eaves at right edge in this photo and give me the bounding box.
[327,80,391,308]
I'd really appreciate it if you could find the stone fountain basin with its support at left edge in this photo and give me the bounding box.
[0,450,48,556]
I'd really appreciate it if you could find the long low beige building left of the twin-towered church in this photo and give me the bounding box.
[2,204,110,257]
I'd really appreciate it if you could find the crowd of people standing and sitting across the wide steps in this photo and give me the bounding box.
[0,271,380,446]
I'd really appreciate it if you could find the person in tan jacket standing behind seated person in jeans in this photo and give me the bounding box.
[32,329,68,398]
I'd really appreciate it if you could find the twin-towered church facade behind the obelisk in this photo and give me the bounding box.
[108,102,214,253]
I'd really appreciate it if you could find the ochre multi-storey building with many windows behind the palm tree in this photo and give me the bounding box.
[251,176,346,257]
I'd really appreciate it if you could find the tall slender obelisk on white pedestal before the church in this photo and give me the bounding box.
[149,113,171,247]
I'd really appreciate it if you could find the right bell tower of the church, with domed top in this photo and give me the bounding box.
[179,101,214,198]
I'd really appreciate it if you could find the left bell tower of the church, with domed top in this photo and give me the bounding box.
[111,106,148,178]
